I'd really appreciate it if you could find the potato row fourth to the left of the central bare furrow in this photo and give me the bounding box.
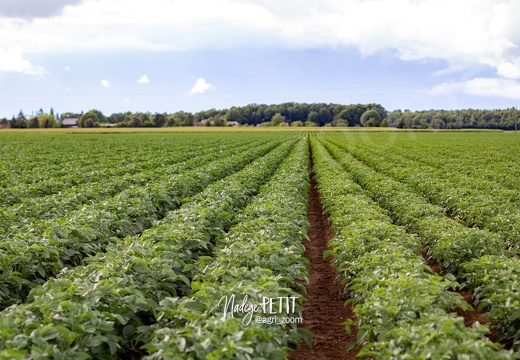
[0,137,251,233]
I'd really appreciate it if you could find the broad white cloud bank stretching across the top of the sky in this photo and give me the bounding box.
[0,0,520,79]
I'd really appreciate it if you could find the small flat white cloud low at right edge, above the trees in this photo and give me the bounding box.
[430,78,520,100]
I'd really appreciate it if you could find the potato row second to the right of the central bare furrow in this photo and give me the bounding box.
[320,137,520,348]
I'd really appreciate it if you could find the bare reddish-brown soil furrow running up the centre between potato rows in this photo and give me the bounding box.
[289,174,359,360]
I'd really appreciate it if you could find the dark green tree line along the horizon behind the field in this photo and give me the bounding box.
[4,103,519,130]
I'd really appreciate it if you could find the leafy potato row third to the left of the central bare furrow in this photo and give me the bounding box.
[0,142,279,309]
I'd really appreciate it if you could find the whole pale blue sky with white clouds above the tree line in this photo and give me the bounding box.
[0,0,520,117]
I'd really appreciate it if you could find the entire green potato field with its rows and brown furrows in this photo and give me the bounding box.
[0,131,520,360]
